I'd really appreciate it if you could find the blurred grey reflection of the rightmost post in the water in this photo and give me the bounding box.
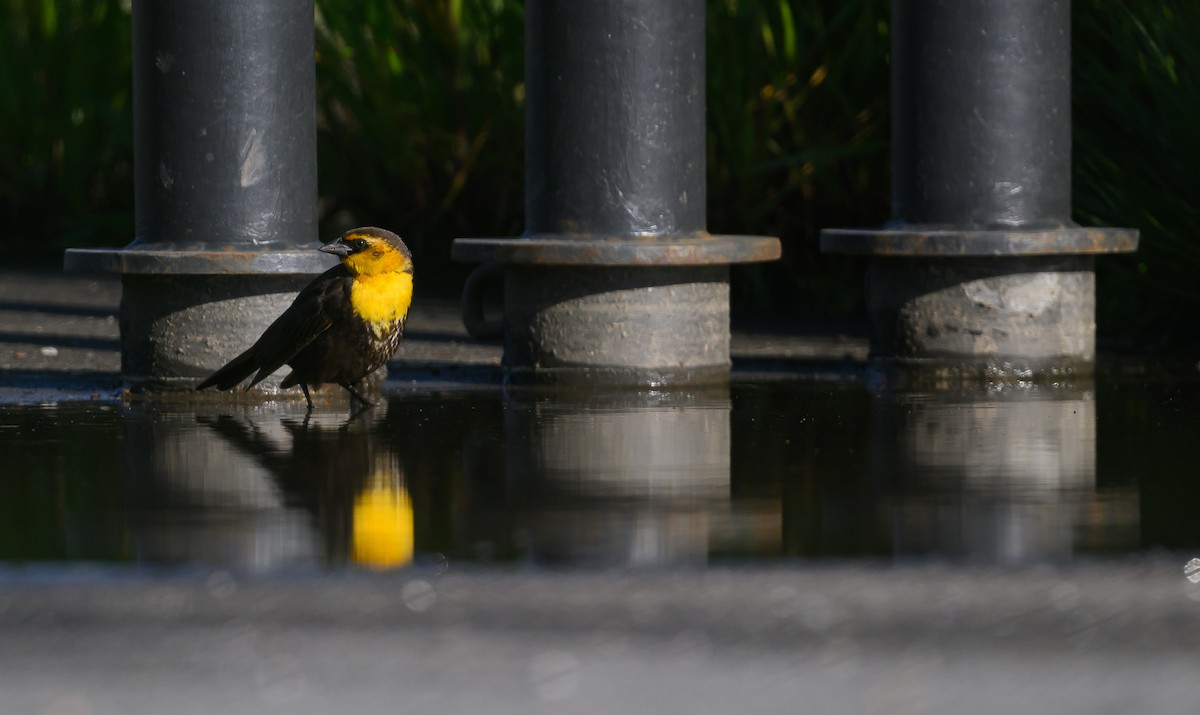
[871,385,1138,563]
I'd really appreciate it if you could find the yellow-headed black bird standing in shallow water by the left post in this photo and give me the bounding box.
[196,228,413,409]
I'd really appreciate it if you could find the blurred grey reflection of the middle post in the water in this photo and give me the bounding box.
[505,387,763,566]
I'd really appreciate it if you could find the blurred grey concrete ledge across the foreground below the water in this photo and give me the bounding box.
[0,558,1200,715]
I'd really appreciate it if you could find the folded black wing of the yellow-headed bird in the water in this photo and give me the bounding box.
[250,265,352,386]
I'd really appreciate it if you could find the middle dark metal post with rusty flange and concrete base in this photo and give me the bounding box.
[452,0,779,386]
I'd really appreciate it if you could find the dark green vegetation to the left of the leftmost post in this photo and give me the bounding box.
[0,0,133,255]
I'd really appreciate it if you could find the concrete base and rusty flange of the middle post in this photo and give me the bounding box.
[454,233,780,387]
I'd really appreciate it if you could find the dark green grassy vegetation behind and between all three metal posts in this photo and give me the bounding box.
[0,0,1200,347]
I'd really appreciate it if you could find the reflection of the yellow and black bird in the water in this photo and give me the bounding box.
[198,414,415,569]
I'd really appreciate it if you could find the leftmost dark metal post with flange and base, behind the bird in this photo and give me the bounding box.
[65,0,330,390]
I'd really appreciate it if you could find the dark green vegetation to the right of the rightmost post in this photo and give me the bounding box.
[1073,0,1200,348]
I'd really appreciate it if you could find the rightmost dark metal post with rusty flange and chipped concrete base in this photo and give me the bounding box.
[821,0,1138,377]
